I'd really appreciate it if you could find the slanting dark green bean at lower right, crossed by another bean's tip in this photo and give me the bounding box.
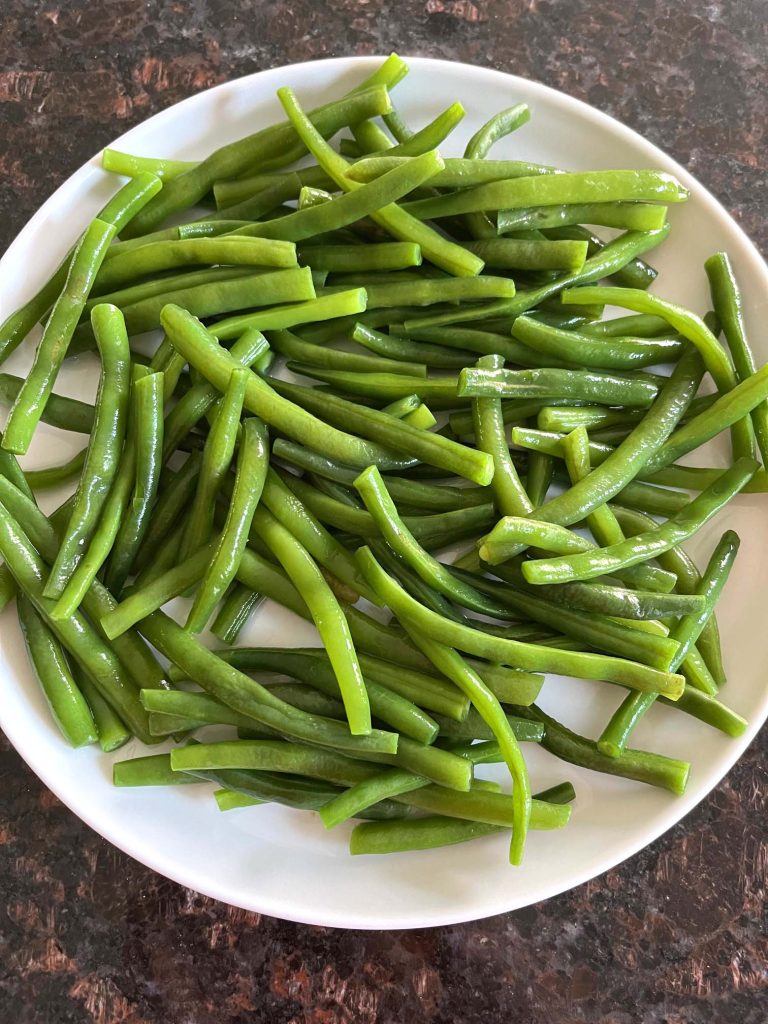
[597,530,740,757]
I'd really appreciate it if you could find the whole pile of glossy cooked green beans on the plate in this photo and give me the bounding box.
[0,54,757,864]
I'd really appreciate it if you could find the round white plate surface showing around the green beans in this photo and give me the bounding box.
[0,57,768,929]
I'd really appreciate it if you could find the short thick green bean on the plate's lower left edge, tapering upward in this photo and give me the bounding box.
[18,594,98,746]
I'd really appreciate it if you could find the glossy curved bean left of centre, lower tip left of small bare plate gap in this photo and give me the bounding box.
[185,415,268,633]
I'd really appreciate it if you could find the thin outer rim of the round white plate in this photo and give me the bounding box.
[0,54,768,931]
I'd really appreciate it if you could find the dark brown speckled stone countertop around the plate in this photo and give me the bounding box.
[0,0,768,1024]
